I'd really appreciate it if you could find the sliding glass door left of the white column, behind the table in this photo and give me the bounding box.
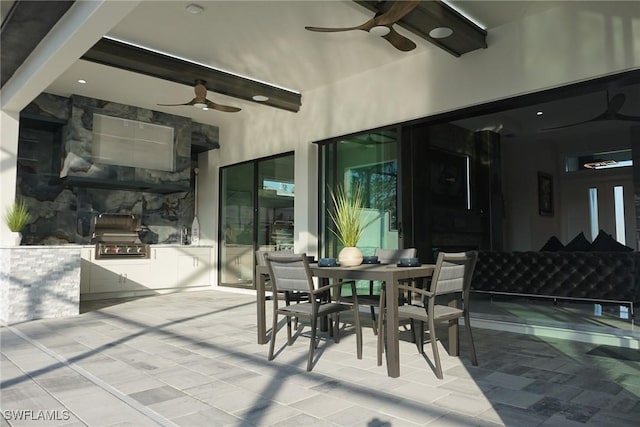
[218,153,295,288]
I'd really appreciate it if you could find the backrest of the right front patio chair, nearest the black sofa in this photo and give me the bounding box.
[431,251,478,296]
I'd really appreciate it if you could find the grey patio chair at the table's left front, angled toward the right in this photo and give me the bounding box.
[265,254,362,371]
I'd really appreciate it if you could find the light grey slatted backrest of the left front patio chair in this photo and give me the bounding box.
[265,253,313,292]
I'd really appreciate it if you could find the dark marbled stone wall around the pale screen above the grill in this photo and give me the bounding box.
[16,93,219,245]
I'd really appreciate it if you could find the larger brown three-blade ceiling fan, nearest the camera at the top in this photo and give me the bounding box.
[305,1,420,52]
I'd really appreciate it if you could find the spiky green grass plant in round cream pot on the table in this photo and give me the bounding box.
[329,185,365,267]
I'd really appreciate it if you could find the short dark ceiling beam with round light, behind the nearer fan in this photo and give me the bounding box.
[354,0,487,57]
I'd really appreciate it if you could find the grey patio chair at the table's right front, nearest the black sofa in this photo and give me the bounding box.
[378,251,478,379]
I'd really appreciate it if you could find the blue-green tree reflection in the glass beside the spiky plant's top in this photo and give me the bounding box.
[349,160,398,230]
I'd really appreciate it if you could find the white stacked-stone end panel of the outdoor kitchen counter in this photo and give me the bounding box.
[0,246,81,324]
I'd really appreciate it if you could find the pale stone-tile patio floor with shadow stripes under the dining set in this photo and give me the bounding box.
[0,290,640,427]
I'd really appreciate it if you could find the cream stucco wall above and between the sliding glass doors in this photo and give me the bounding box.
[207,2,640,283]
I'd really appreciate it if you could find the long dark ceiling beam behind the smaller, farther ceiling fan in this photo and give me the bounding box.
[81,38,302,112]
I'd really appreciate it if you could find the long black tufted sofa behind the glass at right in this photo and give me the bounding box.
[471,251,640,316]
